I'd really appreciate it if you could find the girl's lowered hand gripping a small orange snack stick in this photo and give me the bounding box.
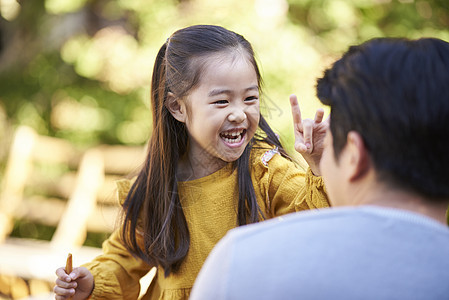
[53,267,94,300]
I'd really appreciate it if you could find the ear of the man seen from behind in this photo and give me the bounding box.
[346,131,372,181]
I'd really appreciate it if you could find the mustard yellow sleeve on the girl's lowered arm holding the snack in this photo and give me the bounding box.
[83,180,152,300]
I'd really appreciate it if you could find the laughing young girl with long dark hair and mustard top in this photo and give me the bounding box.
[54,25,328,300]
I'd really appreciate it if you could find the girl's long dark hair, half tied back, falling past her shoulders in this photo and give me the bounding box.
[122,25,287,276]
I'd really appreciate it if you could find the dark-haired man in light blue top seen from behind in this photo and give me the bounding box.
[191,39,449,300]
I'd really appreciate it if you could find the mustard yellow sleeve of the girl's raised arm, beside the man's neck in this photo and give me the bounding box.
[253,146,329,217]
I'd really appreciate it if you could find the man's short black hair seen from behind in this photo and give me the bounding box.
[317,38,449,205]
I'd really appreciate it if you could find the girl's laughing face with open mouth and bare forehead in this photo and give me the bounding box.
[180,52,260,177]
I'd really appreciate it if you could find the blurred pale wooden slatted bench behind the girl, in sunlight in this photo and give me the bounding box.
[0,126,150,298]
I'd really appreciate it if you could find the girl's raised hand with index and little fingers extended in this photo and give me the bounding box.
[290,95,329,176]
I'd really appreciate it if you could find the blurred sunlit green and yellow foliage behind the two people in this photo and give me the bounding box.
[0,0,449,299]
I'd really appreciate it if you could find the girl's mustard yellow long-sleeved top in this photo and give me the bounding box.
[85,145,329,300]
